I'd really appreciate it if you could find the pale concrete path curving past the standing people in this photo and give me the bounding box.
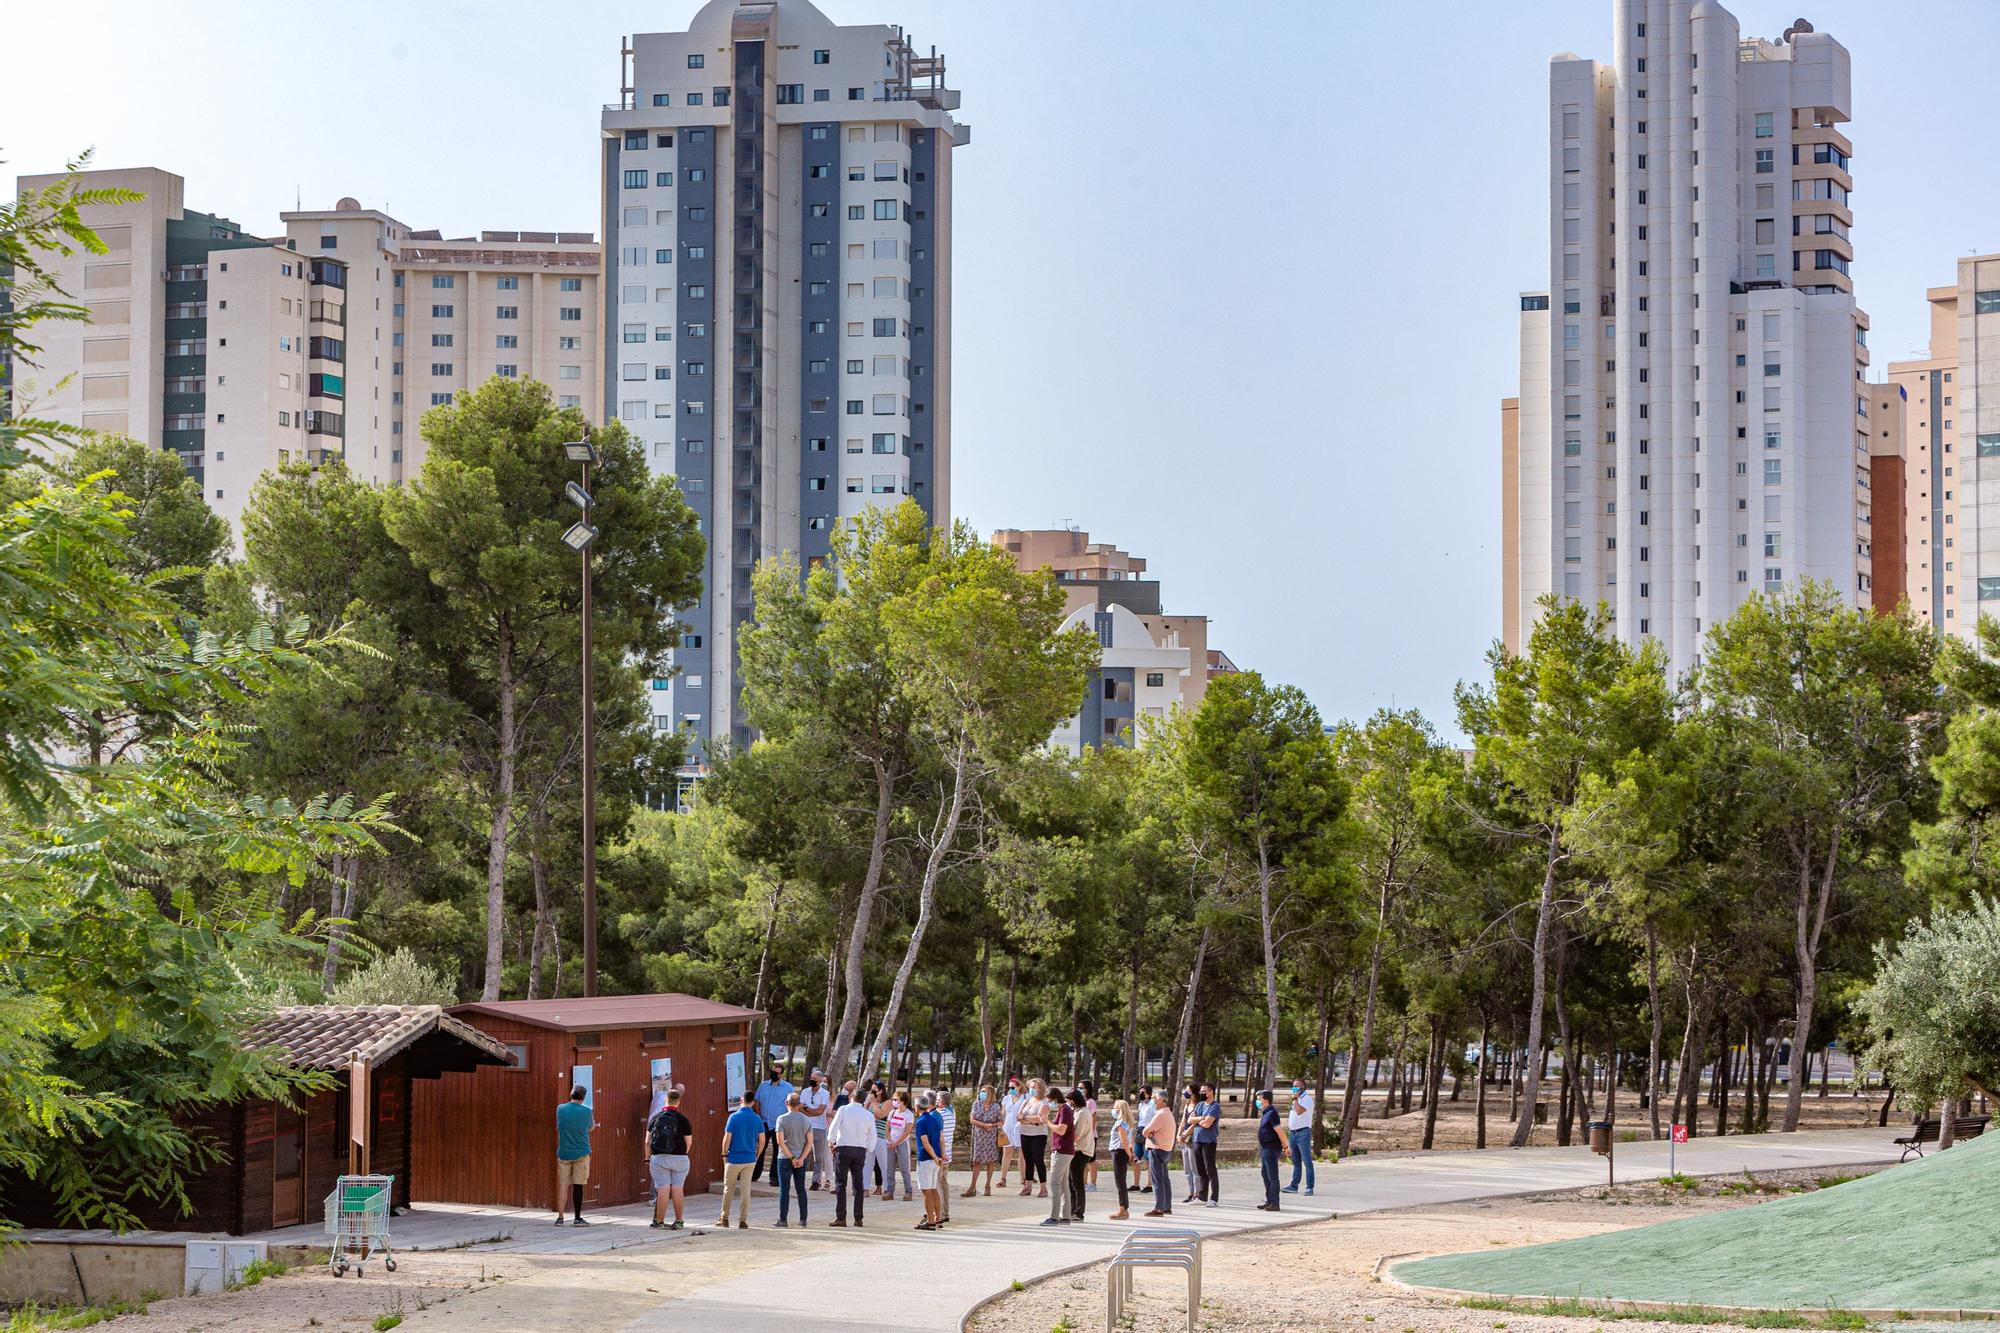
[584,1129,1898,1333]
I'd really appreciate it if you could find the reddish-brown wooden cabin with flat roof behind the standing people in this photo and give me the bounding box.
[412,995,760,1211]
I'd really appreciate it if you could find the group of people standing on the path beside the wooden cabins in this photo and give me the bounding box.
[556,1065,1314,1231]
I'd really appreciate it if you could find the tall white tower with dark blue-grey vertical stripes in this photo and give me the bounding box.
[602,0,970,763]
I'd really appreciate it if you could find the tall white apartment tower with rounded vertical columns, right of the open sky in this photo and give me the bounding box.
[1508,0,1870,675]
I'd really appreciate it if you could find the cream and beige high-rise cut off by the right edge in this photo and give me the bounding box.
[1888,278,2000,638]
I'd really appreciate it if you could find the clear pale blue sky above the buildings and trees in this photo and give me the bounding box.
[0,0,2000,735]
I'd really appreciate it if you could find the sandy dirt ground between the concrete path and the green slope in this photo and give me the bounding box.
[972,1171,1872,1333]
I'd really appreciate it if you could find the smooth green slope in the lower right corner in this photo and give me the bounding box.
[1394,1133,2000,1311]
